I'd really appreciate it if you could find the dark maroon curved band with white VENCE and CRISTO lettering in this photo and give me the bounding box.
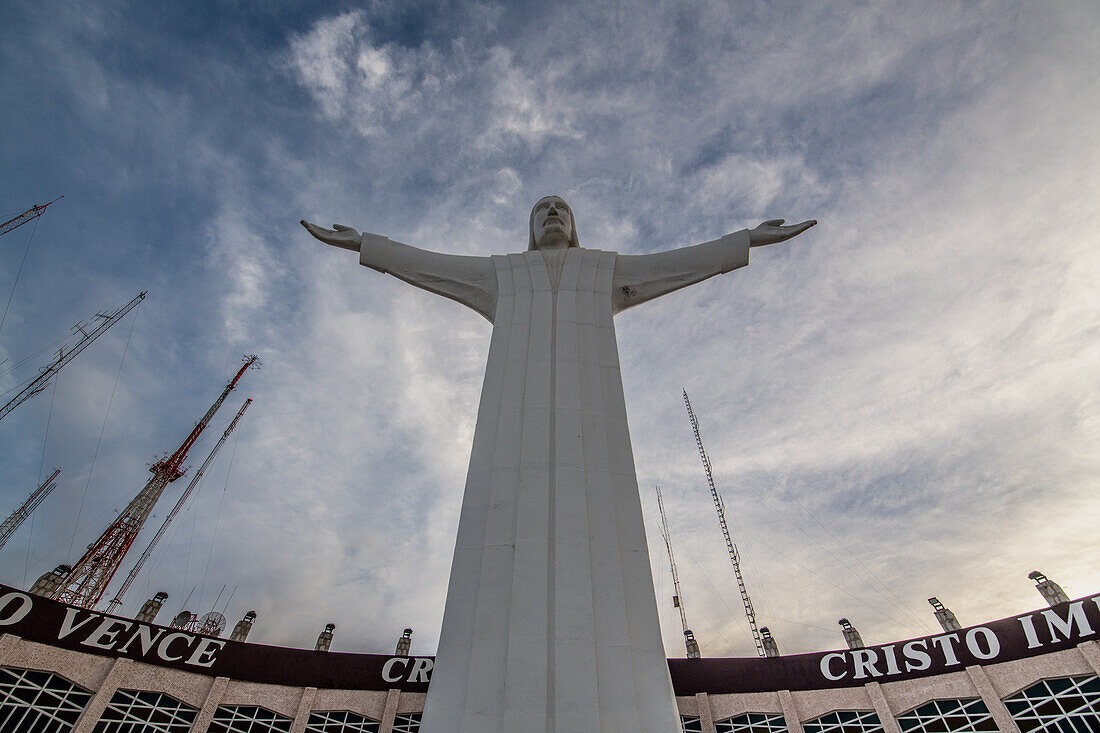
[0,586,1100,694]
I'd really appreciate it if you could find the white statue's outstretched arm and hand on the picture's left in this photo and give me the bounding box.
[301,219,496,321]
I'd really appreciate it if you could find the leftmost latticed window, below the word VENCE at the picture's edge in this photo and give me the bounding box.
[0,667,91,733]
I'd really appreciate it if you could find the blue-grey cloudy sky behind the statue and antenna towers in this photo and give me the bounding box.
[0,0,1100,656]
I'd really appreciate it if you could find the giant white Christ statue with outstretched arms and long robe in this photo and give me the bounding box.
[301,196,816,733]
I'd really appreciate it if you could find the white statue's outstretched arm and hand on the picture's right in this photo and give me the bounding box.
[612,219,817,313]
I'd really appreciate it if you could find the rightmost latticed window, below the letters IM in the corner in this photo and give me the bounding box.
[1004,677,1100,733]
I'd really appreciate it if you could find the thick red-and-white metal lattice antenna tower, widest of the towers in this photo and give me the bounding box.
[51,354,260,609]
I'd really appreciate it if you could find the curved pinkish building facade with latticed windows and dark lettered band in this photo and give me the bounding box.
[0,586,1100,733]
